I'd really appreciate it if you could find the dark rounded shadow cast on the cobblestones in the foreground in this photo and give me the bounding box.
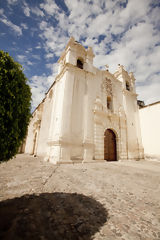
[0,193,108,240]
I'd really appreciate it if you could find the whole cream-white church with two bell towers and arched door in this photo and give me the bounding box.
[24,37,144,164]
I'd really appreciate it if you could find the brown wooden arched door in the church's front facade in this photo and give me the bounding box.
[104,129,117,161]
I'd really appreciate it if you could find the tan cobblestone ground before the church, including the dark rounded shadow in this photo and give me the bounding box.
[0,155,160,240]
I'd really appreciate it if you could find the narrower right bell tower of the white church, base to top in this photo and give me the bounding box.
[114,65,143,159]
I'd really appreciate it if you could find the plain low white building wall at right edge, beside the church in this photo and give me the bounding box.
[139,101,160,159]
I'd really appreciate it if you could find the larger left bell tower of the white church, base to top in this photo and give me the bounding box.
[45,37,95,163]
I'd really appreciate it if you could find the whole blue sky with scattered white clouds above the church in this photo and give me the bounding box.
[0,0,160,110]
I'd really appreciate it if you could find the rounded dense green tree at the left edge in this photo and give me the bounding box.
[0,51,31,161]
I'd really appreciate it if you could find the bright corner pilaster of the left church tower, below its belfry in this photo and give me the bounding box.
[46,68,73,163]
